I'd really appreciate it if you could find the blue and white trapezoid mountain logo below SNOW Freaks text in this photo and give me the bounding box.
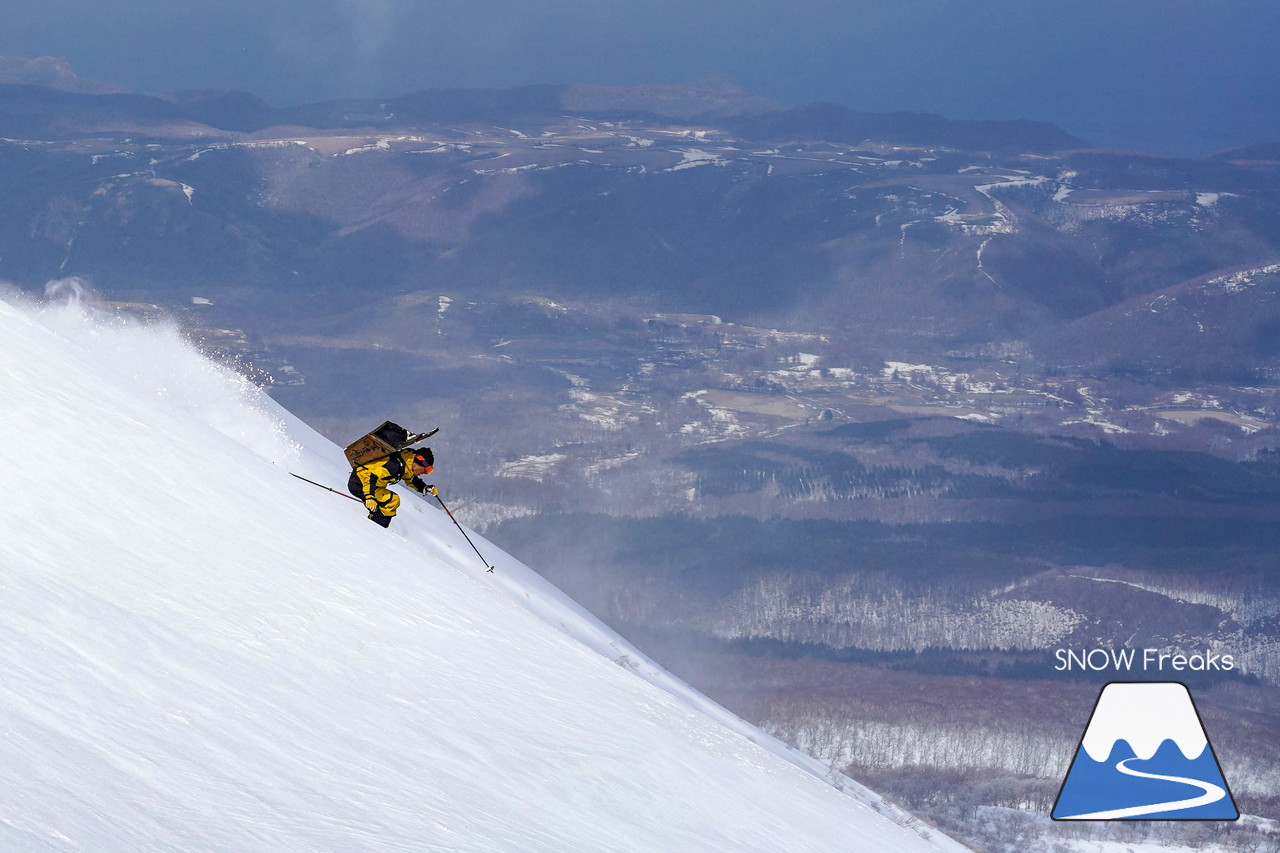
[1051,681,1240,821]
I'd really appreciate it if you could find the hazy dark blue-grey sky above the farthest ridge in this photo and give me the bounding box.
[0,0,1280,155]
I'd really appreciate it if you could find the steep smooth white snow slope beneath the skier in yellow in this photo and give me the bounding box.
[0,290,964,853]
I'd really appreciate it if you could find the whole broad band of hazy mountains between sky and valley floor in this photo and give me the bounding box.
[0,63,1280,377]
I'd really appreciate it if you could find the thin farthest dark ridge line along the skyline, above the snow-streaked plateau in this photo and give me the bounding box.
[0,58,1087,151]
